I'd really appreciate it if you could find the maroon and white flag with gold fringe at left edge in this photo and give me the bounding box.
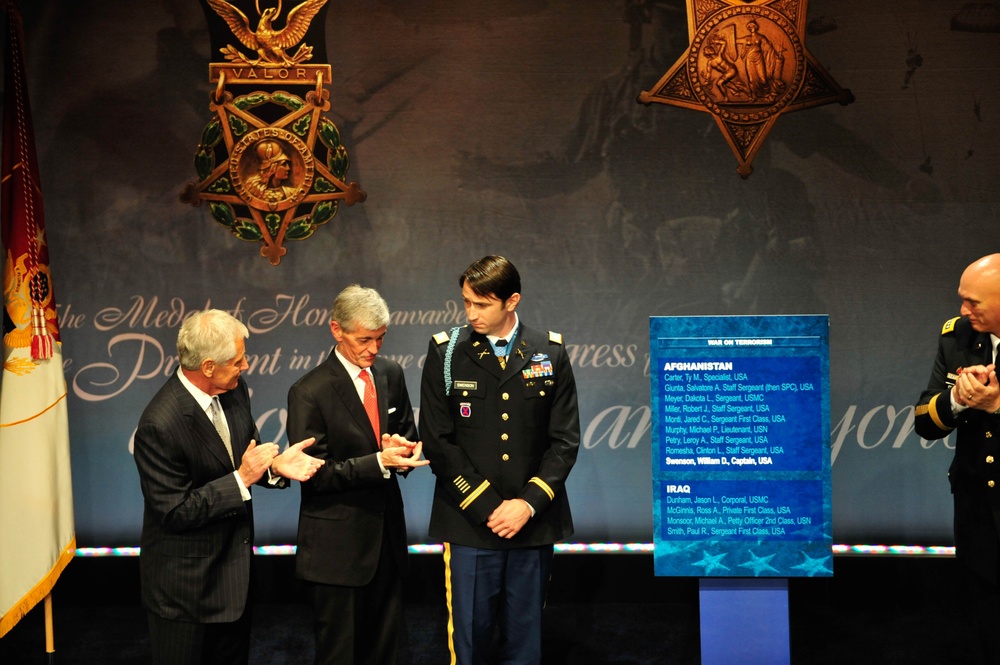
[0,0,76,636]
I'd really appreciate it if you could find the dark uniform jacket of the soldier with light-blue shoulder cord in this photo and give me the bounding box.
[420,323,580,550]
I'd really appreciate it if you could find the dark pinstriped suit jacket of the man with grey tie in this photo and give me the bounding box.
[134,374,274,623]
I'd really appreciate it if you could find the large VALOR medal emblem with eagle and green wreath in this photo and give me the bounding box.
[181,0,366,265]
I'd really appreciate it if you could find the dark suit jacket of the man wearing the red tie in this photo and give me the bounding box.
[288,353,417,586]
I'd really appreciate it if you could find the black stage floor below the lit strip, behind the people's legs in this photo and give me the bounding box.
[0,554,972,665]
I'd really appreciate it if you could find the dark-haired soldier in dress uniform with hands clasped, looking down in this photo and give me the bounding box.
[420,256,580,665]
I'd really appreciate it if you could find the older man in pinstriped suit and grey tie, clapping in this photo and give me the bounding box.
[134,310,323,665]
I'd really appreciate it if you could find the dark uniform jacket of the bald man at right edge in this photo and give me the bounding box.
[913,317,1000,584]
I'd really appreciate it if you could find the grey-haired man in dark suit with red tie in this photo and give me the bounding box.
[288,285,428,665]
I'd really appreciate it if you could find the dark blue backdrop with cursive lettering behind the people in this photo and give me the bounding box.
[5,0,1000,546]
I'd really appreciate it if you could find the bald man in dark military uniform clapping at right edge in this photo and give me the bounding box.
[914,254,1000,664]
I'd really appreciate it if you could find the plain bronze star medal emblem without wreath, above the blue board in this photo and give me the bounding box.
[639,0,854,178]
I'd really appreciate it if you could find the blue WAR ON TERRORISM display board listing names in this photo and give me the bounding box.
[649,315,833,577]
